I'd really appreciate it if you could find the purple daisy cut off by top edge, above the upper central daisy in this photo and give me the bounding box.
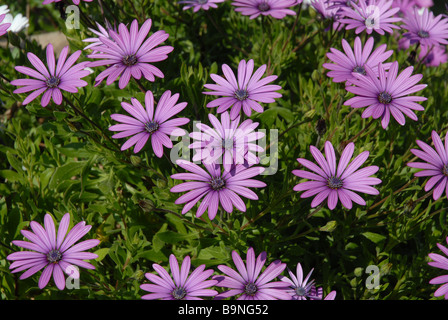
[232,0,302,19]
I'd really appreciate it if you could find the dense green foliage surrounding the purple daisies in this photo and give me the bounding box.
[0,0,448,300]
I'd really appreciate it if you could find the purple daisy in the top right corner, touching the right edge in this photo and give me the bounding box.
[402,8,448,46]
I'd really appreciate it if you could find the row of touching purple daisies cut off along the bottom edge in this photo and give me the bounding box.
[140,248,336,300]
